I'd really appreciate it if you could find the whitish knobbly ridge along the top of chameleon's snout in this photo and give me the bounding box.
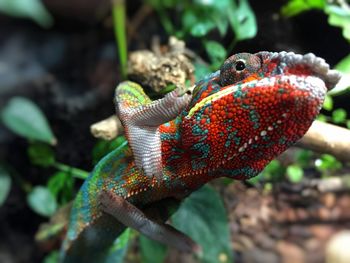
[266,51,341,90]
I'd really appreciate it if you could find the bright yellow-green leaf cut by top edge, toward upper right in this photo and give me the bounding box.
[281,0,326,17]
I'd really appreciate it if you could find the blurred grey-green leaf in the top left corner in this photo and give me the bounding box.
[0,0,53,28]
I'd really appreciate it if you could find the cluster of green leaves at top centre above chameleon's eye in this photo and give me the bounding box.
[147,0,257,67]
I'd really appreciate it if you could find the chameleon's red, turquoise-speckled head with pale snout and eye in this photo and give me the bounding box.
[182,52,340,179]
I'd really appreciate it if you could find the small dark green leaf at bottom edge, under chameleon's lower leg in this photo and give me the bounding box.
[140,235,167,263]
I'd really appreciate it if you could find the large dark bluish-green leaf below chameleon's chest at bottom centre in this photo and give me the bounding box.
[172,186,233,263]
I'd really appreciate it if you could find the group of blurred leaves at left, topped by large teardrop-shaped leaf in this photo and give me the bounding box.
[0,97,88,217]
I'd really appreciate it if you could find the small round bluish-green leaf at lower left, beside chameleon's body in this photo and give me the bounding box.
[27,186,57,217]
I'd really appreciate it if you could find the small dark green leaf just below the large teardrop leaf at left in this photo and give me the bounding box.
[27,142,55,167]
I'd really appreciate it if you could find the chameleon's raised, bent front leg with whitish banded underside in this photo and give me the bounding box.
[115,81,192,179]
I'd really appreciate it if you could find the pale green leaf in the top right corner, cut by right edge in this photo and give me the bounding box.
[325,5,350,41]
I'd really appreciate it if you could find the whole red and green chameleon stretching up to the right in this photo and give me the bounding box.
[61,52,340,263]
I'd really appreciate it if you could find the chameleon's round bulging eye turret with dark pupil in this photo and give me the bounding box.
[220,53,262,87]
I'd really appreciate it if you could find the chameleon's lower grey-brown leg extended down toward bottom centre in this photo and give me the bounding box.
[100,191,201,253]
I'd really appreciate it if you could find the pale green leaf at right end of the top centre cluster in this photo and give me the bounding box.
[227,0,258,41]
